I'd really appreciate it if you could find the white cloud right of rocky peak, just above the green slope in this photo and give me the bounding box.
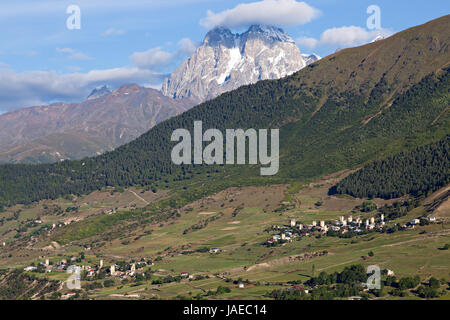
[296,26,392,48]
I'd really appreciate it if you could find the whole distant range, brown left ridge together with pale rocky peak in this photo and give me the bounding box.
[0,26,320,163]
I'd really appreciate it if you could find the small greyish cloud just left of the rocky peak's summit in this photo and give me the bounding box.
[130,38,197,69]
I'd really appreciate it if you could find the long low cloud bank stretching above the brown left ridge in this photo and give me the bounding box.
[0,67,166,111]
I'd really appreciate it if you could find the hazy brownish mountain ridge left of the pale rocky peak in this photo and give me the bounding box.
[0,84,194,163]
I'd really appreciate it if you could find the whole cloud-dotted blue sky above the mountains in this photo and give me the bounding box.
[0,0,450,112]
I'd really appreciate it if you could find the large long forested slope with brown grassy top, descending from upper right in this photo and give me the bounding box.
[0,16,450,204]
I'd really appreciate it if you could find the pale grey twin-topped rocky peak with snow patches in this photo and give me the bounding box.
[162,25,316,102]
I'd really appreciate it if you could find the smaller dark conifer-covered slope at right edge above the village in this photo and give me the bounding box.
[330,135,450,199]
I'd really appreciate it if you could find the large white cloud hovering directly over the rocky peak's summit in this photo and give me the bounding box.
[200,0,320,29]
